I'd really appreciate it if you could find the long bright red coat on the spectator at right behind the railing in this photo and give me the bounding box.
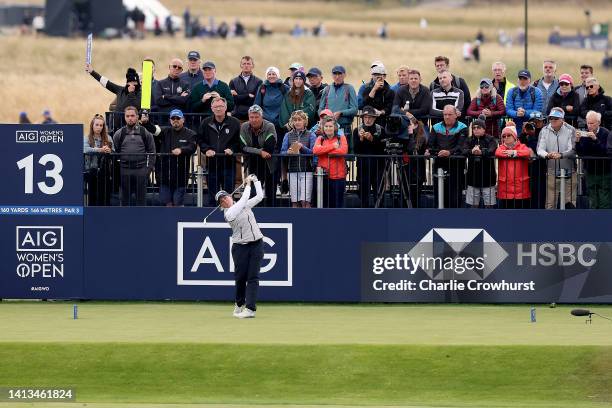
[495,141,531,200]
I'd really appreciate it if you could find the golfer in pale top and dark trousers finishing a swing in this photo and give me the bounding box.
[212,174,264,319]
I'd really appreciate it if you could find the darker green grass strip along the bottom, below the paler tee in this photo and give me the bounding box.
[0,343,612,406]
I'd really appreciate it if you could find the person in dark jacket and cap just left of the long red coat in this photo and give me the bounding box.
[463,118,497,208]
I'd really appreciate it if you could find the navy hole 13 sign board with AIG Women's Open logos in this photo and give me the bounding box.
[0,125,83,299]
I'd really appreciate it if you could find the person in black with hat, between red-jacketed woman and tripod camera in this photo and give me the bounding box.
[353,106,385,208]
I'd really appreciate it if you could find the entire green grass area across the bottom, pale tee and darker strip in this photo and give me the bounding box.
[0,302,612,408]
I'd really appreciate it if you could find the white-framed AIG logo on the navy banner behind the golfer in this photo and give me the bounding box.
[176,222,293,286]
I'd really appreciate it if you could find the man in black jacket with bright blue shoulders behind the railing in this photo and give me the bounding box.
[427,105,468,208]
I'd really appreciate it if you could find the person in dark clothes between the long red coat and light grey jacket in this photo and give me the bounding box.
[519,111,546,209]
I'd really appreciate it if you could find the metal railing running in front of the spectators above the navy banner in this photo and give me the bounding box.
[84,153,612,209]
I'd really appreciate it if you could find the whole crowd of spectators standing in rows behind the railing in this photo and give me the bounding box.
[85,51,612,208]
